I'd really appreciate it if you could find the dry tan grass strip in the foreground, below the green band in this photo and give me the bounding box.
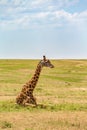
[0,111,87,130]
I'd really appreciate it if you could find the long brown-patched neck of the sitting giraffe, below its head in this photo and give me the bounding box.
[30,63,42,89]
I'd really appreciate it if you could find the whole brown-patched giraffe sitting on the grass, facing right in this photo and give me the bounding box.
[16,56,54,106]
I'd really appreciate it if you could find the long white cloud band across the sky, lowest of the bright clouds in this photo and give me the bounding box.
[1,10,87,28]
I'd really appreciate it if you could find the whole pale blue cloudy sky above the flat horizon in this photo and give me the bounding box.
[0,0,87,59]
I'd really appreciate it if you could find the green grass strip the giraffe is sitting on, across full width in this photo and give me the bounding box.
[0,101,87,112]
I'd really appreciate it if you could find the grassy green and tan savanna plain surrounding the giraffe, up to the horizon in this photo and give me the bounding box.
[0,60,87,130]
